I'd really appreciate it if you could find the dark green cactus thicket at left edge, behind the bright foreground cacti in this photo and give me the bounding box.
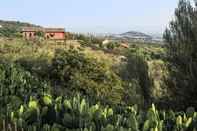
[0,62,50,120]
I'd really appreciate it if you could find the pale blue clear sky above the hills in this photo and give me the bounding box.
[0,0,178,34]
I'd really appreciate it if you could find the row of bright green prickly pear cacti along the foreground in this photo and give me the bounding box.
[0,95,197,131]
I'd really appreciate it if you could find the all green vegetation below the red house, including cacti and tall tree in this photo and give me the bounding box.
[0,0,197,131]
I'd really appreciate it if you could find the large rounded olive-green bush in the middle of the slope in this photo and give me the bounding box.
[50,49,123,103]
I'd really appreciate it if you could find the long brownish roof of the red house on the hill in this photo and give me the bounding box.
[22,27,65,32]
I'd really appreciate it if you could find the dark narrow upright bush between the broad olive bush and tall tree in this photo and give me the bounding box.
[120,51,152,106]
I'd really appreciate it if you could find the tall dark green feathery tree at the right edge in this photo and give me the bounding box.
[163,0,197,106]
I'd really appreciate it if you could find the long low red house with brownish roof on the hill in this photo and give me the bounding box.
[22,27,65,40]
